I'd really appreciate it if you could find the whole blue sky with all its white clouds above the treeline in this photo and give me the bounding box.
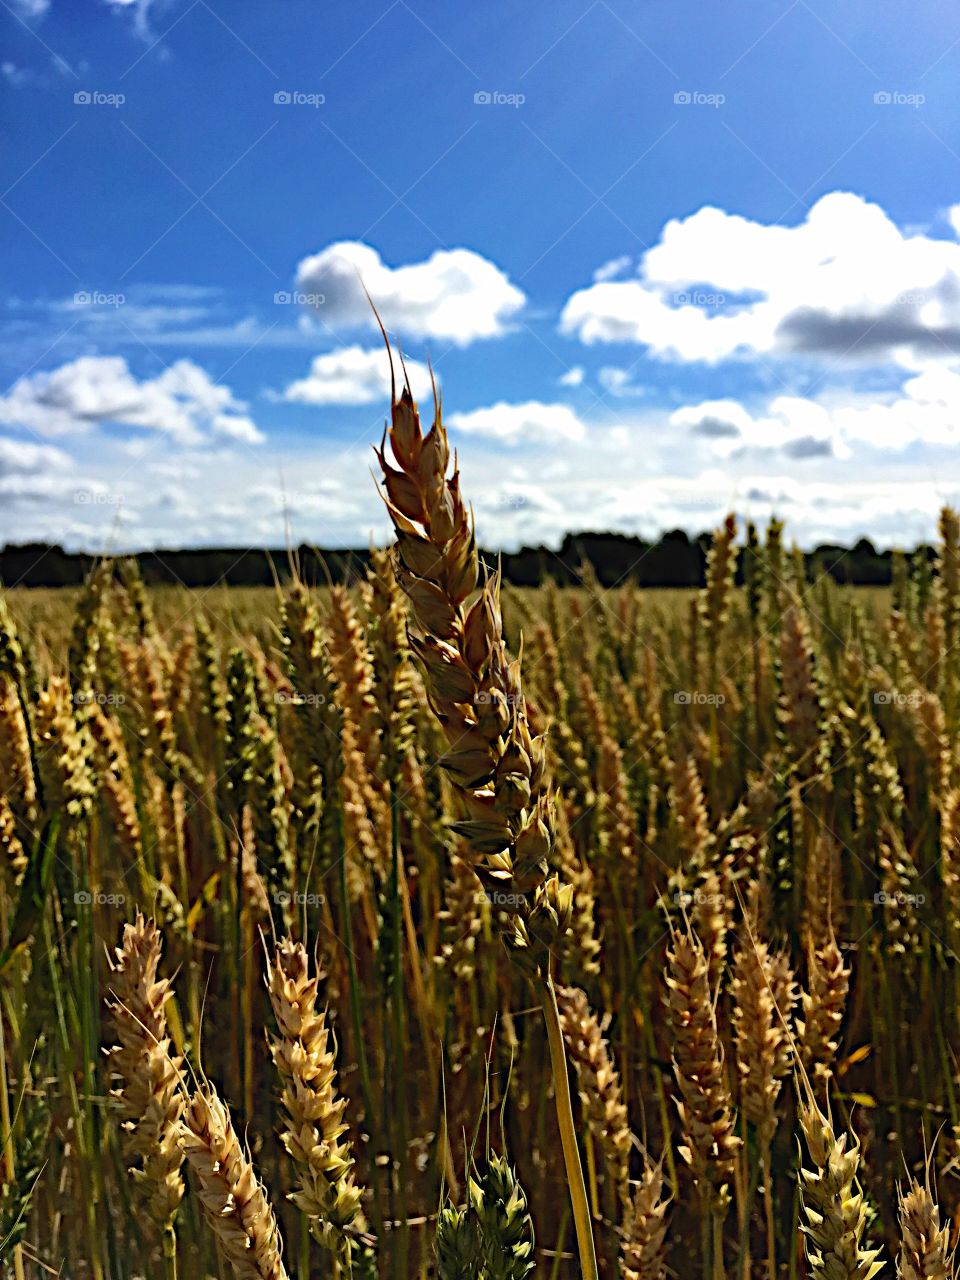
[0,0,960,549]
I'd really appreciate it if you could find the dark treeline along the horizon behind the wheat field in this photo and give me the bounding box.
[0,529,916,588]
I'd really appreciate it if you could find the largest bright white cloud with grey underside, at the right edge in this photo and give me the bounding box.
[561,192,960,367]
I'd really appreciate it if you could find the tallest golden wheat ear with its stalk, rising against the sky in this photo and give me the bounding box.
[378,355,598,1280]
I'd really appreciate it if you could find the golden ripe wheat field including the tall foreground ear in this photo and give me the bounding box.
[0,392,960,1280]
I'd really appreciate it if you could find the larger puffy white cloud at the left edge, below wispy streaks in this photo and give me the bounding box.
[0,356,264,444]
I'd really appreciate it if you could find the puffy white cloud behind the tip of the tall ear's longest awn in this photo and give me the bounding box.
[297,241,526,347]
